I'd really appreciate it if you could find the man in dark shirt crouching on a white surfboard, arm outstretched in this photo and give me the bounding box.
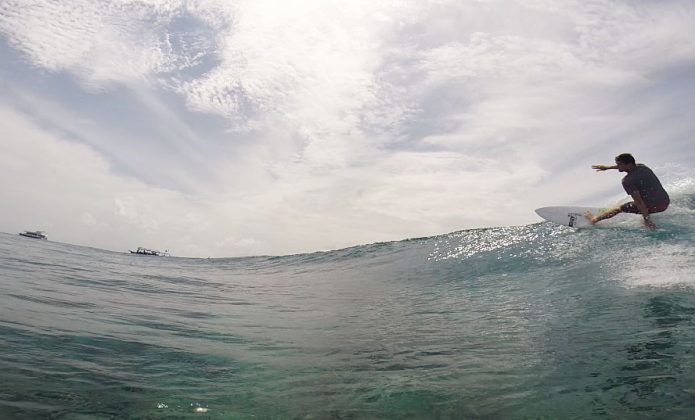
[586,153,671,230]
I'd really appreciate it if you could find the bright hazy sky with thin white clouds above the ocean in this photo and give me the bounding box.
[0,0,695,257]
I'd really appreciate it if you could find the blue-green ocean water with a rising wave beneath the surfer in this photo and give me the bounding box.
[0,179,695,419]
